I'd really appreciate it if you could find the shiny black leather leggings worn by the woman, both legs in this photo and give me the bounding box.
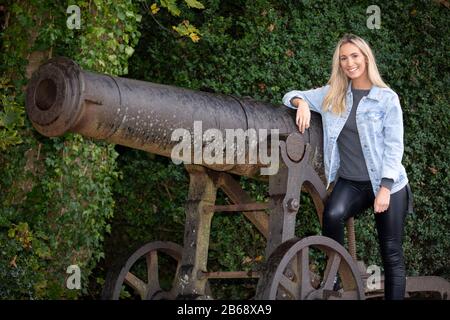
[322,178,408,300]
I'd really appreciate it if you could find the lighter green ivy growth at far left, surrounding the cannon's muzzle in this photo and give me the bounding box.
[0,0,141,299]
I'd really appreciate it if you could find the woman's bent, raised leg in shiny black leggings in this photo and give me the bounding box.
[322,178,374,245]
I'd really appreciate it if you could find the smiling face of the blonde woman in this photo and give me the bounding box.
[339,43,368,81]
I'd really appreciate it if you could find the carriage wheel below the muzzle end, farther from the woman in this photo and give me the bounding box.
[102,241,183,300]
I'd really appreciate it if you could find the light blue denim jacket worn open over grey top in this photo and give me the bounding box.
[283,81,408,195]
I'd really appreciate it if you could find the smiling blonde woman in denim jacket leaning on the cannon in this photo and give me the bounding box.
[283,34,411,299]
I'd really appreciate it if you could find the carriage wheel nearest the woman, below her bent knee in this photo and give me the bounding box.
[256,236,365,300]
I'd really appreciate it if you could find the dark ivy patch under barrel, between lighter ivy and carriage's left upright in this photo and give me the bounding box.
[107,147,188,252]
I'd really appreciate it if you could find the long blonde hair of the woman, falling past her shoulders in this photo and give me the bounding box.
[322,34,388,114]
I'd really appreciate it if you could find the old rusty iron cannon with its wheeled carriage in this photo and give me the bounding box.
[26,57,450,299]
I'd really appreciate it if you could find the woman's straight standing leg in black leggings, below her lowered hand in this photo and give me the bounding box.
[375,187,408,300]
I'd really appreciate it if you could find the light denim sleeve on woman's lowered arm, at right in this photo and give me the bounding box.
[381,95,404,181]
